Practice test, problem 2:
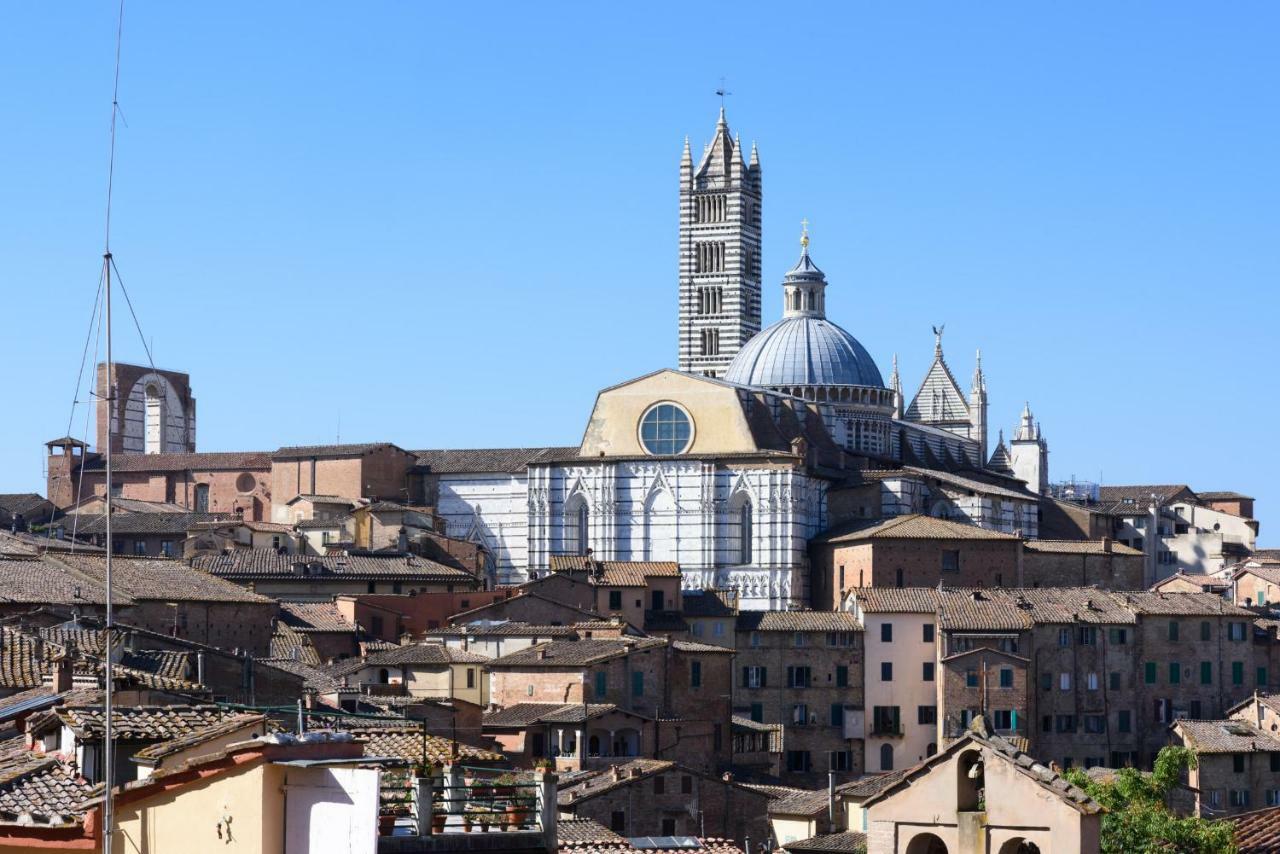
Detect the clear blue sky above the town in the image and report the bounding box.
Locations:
[0,0,1280,542]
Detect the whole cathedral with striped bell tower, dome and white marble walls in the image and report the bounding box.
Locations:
[419,109,1048,609]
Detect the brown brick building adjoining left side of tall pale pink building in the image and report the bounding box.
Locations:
[733,611,864,782]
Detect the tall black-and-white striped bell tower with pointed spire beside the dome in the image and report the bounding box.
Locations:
[678,108,760,376]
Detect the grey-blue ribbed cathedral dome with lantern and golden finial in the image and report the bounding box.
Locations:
[724,233,884,388]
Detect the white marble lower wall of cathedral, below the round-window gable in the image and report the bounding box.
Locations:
[438,460,827,609]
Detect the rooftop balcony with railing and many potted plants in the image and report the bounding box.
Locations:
[378,766,557,854]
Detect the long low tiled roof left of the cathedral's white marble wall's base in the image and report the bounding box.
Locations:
[191,548,475,584]
